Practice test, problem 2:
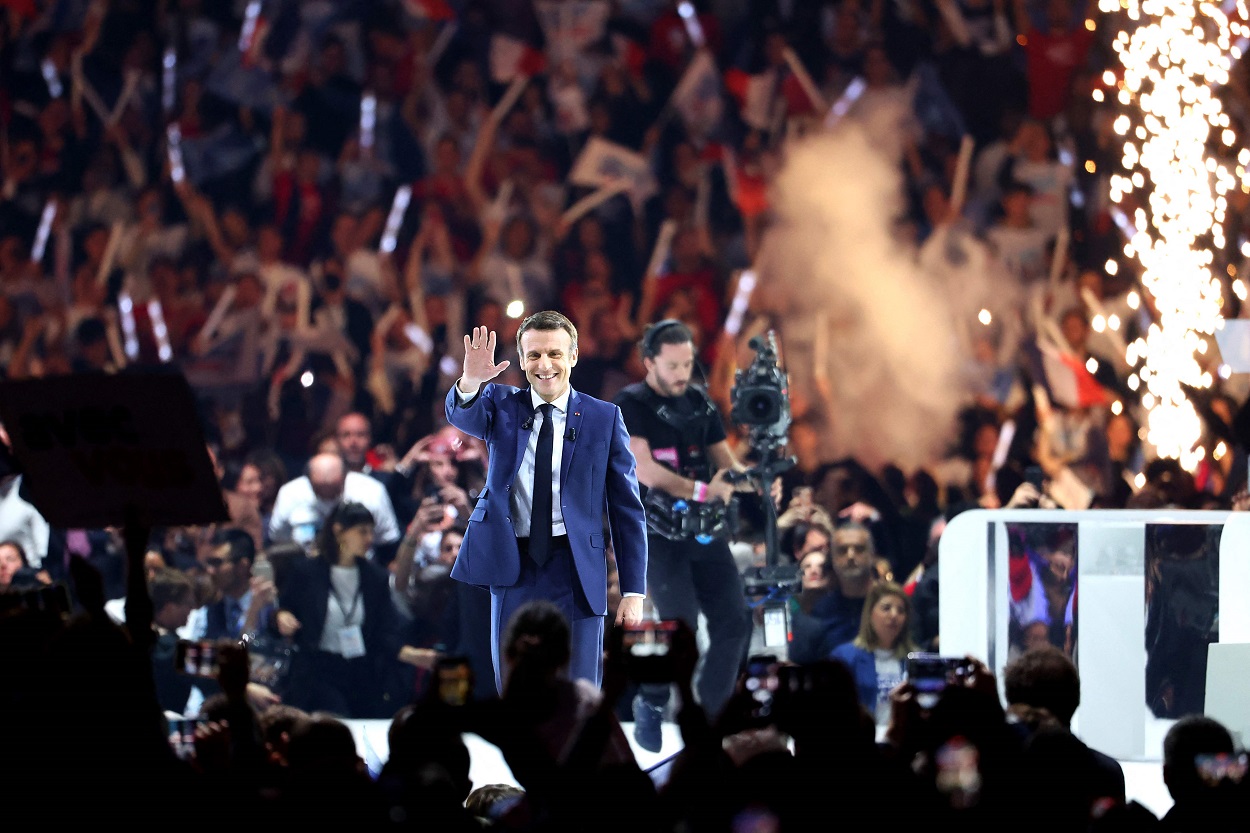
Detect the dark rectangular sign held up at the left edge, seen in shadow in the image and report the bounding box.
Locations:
[0,373,229,529]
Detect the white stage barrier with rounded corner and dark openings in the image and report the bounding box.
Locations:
[939,509,1230,760]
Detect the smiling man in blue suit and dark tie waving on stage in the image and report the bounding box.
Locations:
[446,311,646,692]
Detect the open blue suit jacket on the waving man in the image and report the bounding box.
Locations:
[446,384,646,615]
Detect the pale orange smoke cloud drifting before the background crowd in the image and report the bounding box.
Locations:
[759,121,964,470]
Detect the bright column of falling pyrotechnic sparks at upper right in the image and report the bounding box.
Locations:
[1095,0,1250,469]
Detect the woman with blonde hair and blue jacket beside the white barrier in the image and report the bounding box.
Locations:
[830,582,916,723]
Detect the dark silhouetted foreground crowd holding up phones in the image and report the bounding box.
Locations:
[7,520,1248,830]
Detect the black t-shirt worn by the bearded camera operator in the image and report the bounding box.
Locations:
[614,381,725,494]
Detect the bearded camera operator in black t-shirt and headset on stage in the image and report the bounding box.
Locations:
[615,319,751,752]
